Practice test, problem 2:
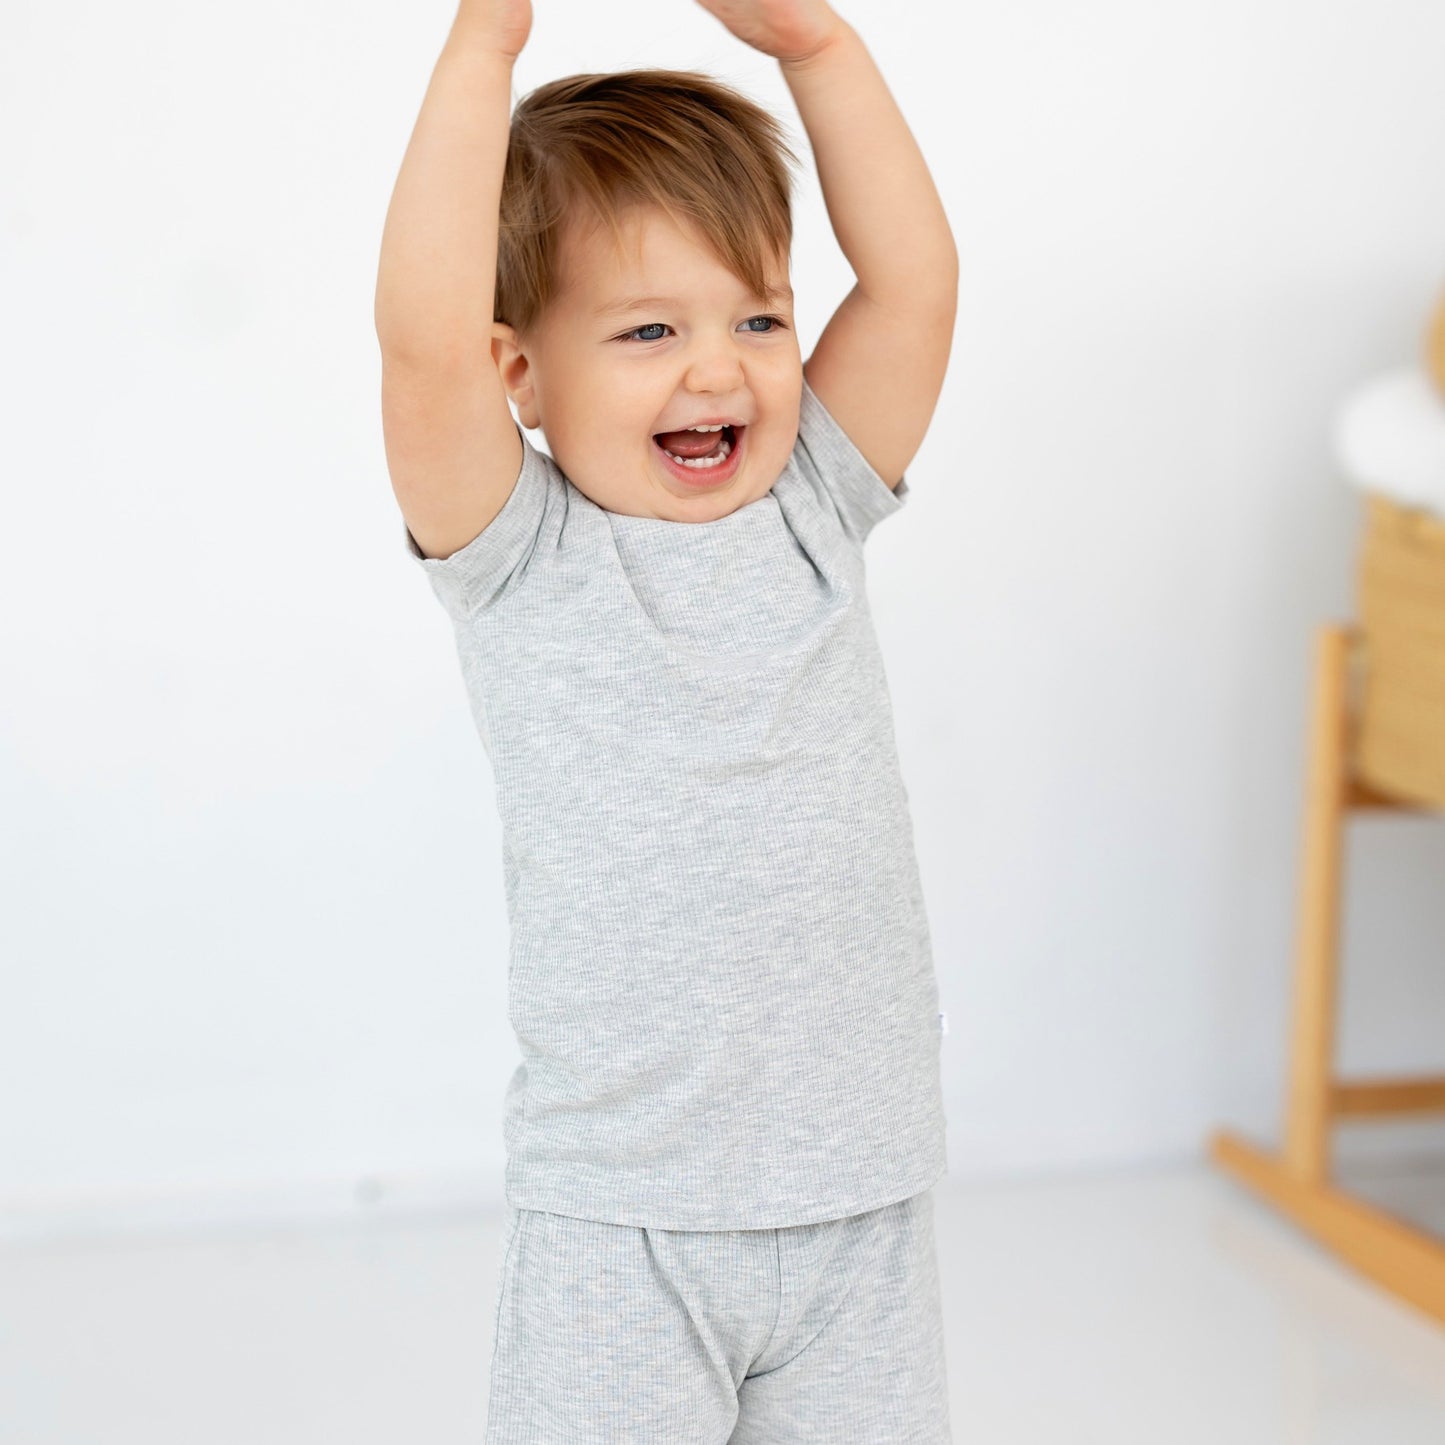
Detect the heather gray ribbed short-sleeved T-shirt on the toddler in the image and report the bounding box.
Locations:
[406,389,946,1230]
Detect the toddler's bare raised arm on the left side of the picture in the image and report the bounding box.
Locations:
[376,0,532,556]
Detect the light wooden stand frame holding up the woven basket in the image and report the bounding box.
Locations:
[1209,623,1445,1324]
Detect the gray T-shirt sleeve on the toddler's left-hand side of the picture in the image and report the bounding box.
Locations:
[403,428,566,620]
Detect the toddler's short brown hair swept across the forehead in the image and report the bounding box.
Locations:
[494,71,796,331]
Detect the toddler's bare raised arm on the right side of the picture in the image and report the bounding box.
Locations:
[699,0,958,487]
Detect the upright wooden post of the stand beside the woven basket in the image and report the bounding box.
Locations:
[1285,624,1354,1183]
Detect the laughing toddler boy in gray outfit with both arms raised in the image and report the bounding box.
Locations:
[376,0,958,1445]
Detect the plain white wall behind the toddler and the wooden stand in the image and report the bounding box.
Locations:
[0,0,1445,1231]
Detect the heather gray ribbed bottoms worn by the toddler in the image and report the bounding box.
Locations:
[486,1189,952,1445]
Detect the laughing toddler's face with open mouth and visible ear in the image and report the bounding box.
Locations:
[497,210,803,522]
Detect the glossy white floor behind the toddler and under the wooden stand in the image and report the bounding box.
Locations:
[0,1166,1445,1445]
